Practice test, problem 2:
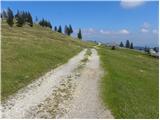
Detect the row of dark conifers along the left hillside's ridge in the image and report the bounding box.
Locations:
[1,8,82,39]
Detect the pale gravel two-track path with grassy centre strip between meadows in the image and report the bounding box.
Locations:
[2,49,113,118]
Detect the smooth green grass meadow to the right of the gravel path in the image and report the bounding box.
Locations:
[98,47,159,118]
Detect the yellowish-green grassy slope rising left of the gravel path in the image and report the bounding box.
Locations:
[1,23,93,100]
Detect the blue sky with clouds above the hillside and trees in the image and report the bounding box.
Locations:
[1,0,159,46]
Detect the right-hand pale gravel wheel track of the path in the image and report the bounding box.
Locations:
[61,49,113,119]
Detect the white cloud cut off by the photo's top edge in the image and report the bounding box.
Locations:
[120,0,144,8]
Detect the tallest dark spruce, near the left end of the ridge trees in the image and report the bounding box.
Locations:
[7,8,14,27]
